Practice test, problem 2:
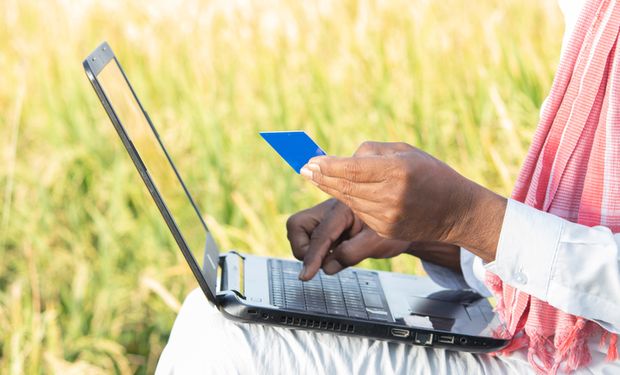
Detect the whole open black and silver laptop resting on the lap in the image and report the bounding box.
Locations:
[83,42,509,352]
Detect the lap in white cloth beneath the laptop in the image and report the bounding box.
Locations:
[156,289,532,375]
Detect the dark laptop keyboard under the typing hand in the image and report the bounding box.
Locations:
[269,259,391,321]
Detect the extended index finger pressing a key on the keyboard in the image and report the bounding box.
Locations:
[299,205,353,281]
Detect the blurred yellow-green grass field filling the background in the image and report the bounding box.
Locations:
[0,0,563,374]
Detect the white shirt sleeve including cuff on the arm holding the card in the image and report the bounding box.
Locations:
[484,200,620,333]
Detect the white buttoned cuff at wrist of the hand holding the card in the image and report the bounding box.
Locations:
[485,199,564,301]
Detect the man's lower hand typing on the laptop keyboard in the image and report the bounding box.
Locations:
[286,199,410,281]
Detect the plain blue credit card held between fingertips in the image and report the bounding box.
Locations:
[260,130,326,173]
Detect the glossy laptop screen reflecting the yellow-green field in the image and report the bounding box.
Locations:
[88,47,219,295]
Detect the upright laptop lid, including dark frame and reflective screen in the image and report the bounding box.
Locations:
[83,42,219,303]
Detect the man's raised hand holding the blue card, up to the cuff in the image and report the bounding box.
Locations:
[302,142,506,261]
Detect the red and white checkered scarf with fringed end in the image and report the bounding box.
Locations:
[486,0,620,373]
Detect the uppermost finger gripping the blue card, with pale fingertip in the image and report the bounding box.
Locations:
[302,155,395,182]
